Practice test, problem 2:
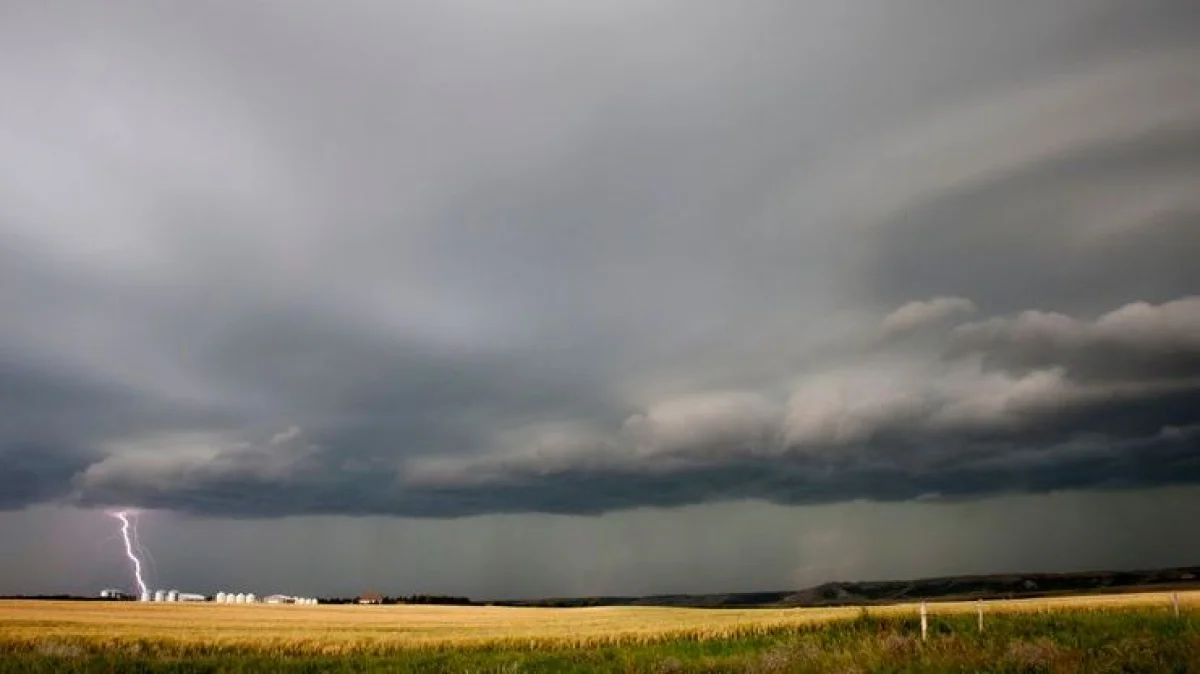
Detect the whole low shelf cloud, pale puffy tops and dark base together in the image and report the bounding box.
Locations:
[68,347,1200,517]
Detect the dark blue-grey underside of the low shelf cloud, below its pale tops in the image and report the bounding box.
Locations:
[68,392,1200,518]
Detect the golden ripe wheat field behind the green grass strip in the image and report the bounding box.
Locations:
[0,591,1200,654]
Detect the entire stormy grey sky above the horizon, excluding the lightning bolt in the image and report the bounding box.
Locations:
[0,0,1200,598]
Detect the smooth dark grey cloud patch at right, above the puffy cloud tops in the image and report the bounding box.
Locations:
[868,128,1200,312]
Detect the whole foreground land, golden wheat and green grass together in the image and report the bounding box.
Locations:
[0,594,1200,673]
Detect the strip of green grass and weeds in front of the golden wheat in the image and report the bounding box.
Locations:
[0,609,1200,674]
